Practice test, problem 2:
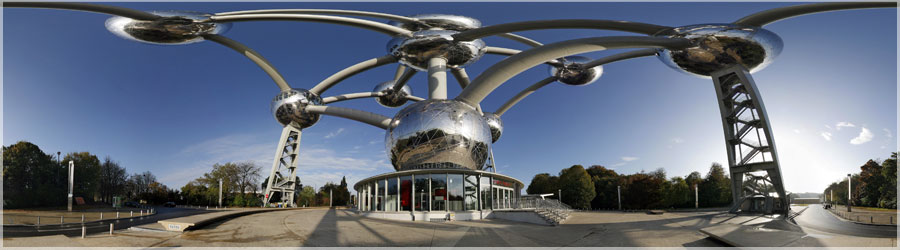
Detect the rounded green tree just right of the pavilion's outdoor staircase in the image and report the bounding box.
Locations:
[559,165,596,209]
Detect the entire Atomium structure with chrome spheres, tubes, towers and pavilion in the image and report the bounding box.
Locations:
[3,2,897,218]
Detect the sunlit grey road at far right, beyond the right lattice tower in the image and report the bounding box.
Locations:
[794,204,897,238]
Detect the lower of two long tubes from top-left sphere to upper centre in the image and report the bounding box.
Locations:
[209,14,412,36]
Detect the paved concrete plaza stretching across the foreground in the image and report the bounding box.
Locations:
[3,209,896,247]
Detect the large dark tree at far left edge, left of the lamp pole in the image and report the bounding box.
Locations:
[3,141,68,208]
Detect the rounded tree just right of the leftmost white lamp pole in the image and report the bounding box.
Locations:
[62,152,100,200]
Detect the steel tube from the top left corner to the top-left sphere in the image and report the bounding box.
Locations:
[3,2,160,21]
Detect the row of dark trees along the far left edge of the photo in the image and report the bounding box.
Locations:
[3,141,177,208]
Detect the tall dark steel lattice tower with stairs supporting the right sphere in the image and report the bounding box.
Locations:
[711,65,788,215]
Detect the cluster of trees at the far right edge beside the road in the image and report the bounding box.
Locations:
[822,152,897,209]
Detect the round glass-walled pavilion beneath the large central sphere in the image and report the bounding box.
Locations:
[354,171,521,212]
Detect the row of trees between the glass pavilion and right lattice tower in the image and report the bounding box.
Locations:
[526,163,732,210]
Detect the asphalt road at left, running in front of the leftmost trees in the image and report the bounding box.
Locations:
[3,207,214,237]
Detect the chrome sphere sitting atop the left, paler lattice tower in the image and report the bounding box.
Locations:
[271,89,322,128]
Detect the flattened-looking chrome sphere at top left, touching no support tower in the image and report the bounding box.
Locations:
[106,11,231,45]
